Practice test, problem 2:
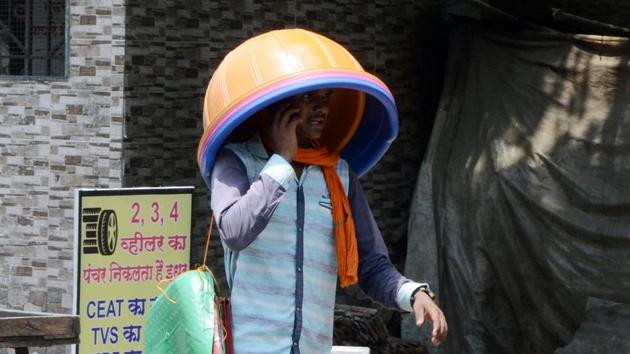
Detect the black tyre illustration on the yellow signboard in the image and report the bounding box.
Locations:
[82,208,118,256]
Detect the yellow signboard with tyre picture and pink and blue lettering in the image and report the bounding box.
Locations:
[74,187,193,354]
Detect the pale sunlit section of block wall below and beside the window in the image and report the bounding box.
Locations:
[0,0,125,353]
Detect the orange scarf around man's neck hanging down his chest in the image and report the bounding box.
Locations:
[294,147,359,288]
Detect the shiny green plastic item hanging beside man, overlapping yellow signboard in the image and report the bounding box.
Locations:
[144,267,218,354]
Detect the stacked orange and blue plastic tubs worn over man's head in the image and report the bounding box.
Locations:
[197,29,398,185]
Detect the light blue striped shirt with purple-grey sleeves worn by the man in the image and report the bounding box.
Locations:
[211,136,421,354]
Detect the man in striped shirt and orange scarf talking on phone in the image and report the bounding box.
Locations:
[211,90,447,354]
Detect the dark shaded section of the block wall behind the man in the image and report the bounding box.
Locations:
[123,0,445,301]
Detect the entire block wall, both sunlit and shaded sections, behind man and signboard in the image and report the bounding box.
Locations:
[0,0,450,353]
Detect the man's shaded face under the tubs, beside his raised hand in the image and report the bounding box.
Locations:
[291,89,332,147]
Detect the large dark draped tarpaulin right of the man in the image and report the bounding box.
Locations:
[406,15,630,354]
